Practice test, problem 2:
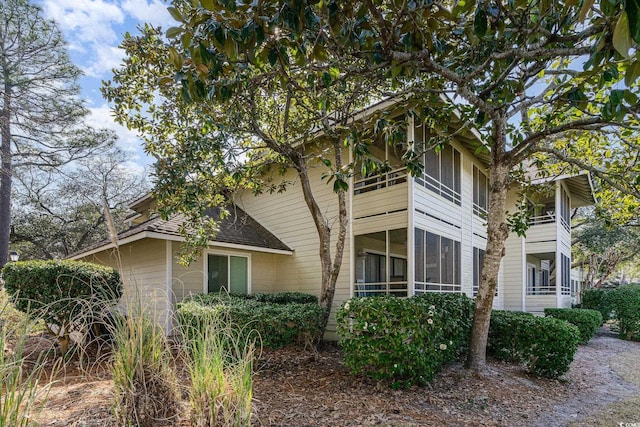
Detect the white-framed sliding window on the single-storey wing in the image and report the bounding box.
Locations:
[207,254,249,294]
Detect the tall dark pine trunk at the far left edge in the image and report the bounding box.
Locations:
[0,78,12,269]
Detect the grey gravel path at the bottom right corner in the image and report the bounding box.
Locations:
[530,326,640,427]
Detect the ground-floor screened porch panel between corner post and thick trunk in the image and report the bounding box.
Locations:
[415,228,462,292]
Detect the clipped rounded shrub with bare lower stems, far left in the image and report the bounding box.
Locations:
[2,260,122,354]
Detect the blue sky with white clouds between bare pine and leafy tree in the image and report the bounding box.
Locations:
[37,0,175,166]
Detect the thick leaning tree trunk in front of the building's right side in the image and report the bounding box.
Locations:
[466,159,510,372]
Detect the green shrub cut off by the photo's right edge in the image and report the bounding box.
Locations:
[609,285,640,341]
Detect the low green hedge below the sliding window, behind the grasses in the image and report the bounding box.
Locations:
[176,294,325,348]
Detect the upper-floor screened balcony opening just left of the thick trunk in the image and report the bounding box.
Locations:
[416,144,461,206]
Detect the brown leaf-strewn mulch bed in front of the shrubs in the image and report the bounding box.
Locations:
[27,326,636,427]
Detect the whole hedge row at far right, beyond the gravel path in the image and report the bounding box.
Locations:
[582,285,640,341]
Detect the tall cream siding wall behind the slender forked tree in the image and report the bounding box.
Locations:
[234,152,351,338]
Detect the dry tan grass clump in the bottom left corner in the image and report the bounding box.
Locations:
[0,300,60,427]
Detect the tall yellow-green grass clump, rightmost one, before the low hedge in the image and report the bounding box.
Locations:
[183,305,257,427]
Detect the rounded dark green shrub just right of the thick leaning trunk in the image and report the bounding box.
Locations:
[487,310,580,378]
